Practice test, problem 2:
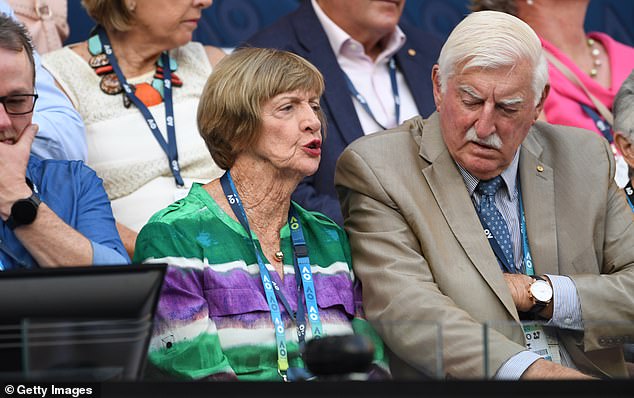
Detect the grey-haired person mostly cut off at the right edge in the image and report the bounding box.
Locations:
[614,70,634,211]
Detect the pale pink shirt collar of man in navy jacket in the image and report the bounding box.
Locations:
[311,0,407,63]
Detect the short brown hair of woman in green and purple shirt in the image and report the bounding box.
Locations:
[198,48,326,170]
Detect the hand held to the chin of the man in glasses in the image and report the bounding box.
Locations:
[0,124,38,221]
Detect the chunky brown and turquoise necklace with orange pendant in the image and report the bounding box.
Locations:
[88,34,183,108]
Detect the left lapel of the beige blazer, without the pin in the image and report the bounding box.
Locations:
[420,113,519,321]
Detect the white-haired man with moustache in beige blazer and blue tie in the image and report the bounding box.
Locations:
[336,11,634,379]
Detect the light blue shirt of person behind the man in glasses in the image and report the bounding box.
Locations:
[0,0,86,160]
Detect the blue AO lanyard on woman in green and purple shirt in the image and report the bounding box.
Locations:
[220,170,323,380]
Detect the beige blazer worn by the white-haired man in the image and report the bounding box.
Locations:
[335,114,634,378]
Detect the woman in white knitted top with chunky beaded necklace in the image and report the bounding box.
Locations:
[43,0,224,255]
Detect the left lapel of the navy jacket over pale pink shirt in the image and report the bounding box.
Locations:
[292,1,363,144]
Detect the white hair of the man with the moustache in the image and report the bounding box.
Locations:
[438,11,548,105]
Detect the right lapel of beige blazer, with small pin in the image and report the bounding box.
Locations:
[520,127,559,274]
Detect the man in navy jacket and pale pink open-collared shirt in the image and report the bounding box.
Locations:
[242,0,441,224]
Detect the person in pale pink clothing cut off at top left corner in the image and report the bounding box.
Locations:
[8,0,70,54]
